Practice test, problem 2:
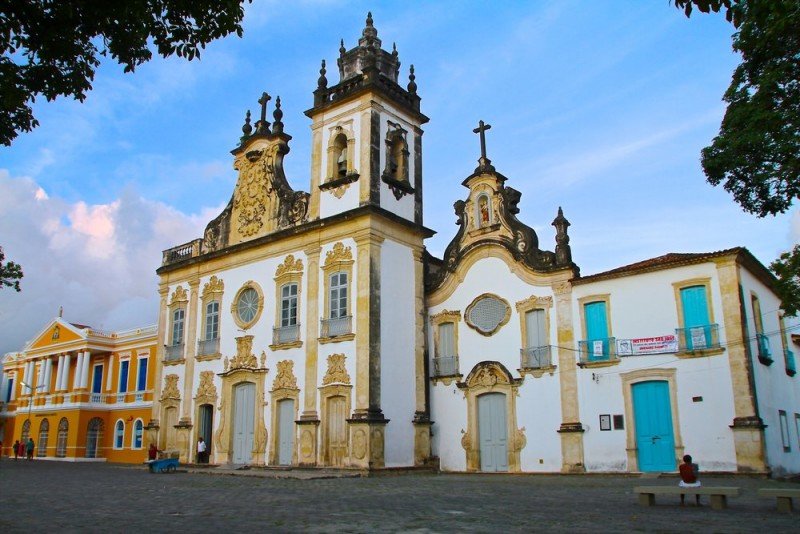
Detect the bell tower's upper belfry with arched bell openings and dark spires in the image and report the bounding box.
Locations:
[306,13,428,225]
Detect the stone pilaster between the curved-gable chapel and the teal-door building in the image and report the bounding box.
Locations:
[553,281,586,473]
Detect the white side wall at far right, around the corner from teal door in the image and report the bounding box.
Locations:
[739,269,800,476]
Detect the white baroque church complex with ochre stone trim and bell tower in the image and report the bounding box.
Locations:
[1,15,800,474]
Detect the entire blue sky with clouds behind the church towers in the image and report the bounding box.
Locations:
[0,0,800,354]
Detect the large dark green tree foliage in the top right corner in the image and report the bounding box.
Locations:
[675,0,800,217]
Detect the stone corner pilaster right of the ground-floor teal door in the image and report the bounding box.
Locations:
[717,256,768,473]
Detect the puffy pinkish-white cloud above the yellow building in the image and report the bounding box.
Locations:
[0,169,221,354]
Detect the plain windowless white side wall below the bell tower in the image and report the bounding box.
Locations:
[380,239,417,467]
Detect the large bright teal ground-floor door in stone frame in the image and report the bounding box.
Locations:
[633,380,675,472]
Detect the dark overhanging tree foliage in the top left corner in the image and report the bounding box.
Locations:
[0,0,252,145]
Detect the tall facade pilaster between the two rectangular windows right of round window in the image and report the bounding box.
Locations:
[296,245,324,465]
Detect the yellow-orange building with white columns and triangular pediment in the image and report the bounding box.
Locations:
[0,317,156,462]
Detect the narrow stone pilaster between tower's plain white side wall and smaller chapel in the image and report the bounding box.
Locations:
[413,249,432,465]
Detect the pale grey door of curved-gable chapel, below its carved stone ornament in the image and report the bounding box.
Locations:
[478,393,508,471]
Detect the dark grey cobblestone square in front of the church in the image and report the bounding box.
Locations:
[0,458,800,533]
